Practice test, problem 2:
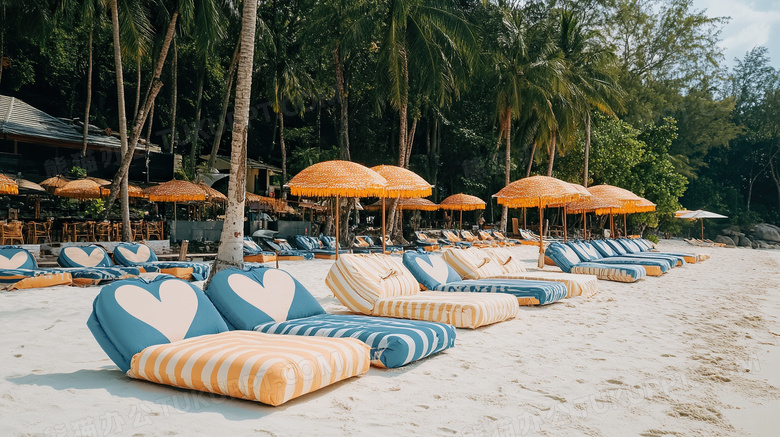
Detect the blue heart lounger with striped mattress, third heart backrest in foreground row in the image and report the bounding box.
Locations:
[404,249,567,305]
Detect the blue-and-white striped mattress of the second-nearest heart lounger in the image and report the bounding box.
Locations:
[255,314,455,368]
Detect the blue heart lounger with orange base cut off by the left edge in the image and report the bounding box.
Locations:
[0,246,73,290]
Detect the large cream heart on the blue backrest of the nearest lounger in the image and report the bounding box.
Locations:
[114,280,203,342]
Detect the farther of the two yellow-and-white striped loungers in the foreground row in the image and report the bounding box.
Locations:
[482,248,599,297]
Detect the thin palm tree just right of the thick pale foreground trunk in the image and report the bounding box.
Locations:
[258,1,314,183]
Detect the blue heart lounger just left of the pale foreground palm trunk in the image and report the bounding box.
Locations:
[114,243,211,281]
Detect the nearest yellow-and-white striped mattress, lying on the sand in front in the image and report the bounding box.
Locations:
[127,331,369,405]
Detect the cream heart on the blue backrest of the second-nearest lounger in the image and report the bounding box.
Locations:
[228,270,295,322]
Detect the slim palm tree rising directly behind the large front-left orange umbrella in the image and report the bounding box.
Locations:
[310,0,374,161]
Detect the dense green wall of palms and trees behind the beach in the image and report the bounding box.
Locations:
[0,0,780,238]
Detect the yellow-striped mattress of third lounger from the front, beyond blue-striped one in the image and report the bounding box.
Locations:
[372,292,517,329]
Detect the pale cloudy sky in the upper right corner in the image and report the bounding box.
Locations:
[693,0,780,69]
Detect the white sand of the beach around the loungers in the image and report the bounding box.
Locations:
[0,241,780,436]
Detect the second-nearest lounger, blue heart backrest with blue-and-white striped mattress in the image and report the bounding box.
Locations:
[206,268,455,368]
